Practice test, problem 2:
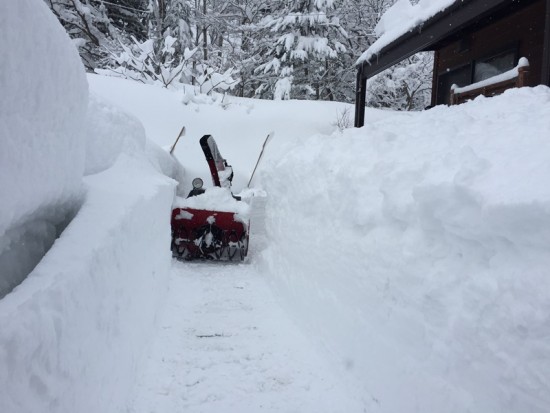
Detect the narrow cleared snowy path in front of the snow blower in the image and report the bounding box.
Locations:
[129,198,364,413]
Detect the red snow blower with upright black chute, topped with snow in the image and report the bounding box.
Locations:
[172,135,249,261]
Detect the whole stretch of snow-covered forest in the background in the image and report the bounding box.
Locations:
[44,0,431,109]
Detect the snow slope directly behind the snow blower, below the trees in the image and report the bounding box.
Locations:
[88,75,353,192]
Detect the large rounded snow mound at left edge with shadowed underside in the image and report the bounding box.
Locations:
[0,0,88,297]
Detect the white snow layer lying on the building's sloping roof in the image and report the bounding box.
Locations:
[356,0,469,65]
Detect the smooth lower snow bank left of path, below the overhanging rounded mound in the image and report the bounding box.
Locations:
[0,156,174,413]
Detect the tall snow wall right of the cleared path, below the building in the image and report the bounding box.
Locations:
[262,87,550,413]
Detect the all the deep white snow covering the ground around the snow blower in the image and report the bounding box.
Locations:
[0,0,550,413]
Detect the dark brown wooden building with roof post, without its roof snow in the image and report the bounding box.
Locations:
[355,0,550,127]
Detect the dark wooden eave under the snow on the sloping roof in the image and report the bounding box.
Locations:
[357,0,548,79]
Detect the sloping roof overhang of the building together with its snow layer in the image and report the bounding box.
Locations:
[356,0,533,77]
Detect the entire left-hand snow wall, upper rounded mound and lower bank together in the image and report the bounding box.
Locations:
[0,0,178,413]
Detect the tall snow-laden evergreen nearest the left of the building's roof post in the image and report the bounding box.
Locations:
[257,0,347,100]
